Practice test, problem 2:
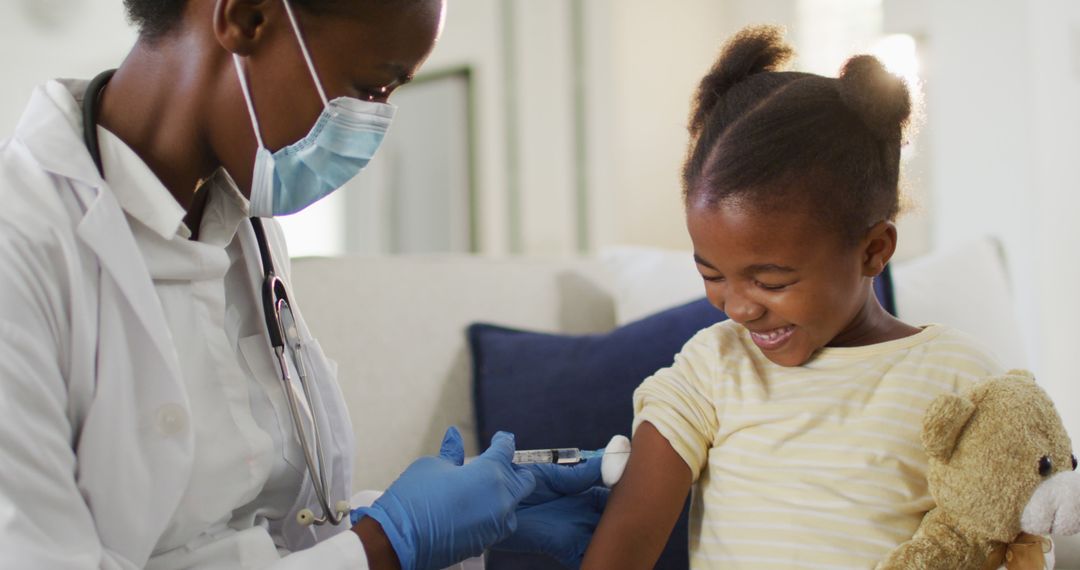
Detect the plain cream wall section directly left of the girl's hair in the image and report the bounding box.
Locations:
[588,0,727,248]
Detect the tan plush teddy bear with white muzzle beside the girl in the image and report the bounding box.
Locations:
[877,370,1080,570]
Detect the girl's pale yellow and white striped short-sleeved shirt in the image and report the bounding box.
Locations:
[634,321,1001,570]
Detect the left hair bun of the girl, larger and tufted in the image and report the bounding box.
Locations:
[689,26,795,135]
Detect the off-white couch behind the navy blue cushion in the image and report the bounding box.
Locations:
[293,241,1080,570]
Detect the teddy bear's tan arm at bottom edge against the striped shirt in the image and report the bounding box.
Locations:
[876,512,985,570]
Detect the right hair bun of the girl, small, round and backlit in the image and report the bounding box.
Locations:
[840,55,912,140]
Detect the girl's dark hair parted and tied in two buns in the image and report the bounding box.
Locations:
[683,27,912,243]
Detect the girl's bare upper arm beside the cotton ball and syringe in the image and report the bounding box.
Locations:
[581,422,693,570]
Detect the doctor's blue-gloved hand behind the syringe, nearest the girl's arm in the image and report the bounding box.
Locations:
[492,460,609,568]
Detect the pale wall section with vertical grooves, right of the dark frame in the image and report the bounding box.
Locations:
[414,0,578,255]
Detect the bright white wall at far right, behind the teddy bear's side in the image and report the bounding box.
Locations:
[886,0,1080,436]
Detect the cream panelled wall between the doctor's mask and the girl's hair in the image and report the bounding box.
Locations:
[428,0,734,255]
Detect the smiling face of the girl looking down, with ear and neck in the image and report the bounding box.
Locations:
[687,199,899,366]
